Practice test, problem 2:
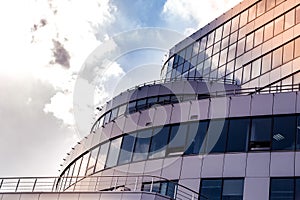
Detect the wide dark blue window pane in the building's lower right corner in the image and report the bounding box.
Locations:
[270,178,294,200]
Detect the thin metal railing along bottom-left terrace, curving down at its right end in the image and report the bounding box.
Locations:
[0,175,206,200]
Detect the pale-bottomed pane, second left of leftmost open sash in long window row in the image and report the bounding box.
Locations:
[132,129,152,161]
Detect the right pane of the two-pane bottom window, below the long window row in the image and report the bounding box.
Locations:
[222,179,244,200]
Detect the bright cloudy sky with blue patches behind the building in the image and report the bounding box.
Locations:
[0,0,239,176]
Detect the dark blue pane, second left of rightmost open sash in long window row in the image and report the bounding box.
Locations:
[206,119,228,153]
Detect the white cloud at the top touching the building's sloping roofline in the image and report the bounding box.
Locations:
[162,0,241,35]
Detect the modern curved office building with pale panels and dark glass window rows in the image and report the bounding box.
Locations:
[0,0,300,200]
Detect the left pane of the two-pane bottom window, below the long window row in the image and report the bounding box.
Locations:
[200,179,222,200]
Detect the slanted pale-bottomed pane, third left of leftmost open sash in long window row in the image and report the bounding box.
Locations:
[118,134,136,165]
